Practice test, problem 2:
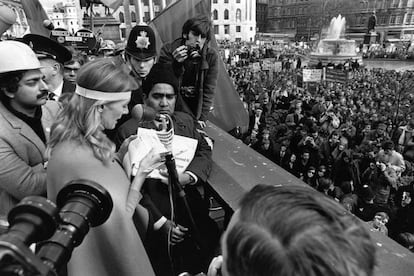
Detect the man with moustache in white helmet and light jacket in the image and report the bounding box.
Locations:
[0,41,60,232]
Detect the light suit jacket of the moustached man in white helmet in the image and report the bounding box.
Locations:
[0,101,60,219]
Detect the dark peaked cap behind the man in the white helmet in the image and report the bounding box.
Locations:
[21,34,72,64]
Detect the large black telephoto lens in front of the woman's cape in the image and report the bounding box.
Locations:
[37,179,113,271]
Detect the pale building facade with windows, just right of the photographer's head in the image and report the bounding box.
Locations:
[211,0,256,42]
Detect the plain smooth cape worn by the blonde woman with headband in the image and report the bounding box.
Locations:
[47,141,154,276]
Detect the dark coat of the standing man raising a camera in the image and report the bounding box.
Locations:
[159,38,219,121]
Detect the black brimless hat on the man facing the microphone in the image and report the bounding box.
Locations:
[142,63,179,95]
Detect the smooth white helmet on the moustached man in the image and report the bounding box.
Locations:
[0,40,41,73]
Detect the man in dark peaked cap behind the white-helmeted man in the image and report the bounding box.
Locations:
[22,34,75,100]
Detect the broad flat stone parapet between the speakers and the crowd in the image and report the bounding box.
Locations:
[206,123,414,276]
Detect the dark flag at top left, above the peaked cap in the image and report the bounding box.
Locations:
[22,0,50,37]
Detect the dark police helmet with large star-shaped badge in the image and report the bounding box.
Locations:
[125,25,157,59]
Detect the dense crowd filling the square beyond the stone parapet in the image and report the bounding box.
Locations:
[228,41,414,248]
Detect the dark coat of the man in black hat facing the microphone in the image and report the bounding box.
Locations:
[117,112,215,275]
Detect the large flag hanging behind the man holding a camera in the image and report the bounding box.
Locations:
[149,0,249,132]
